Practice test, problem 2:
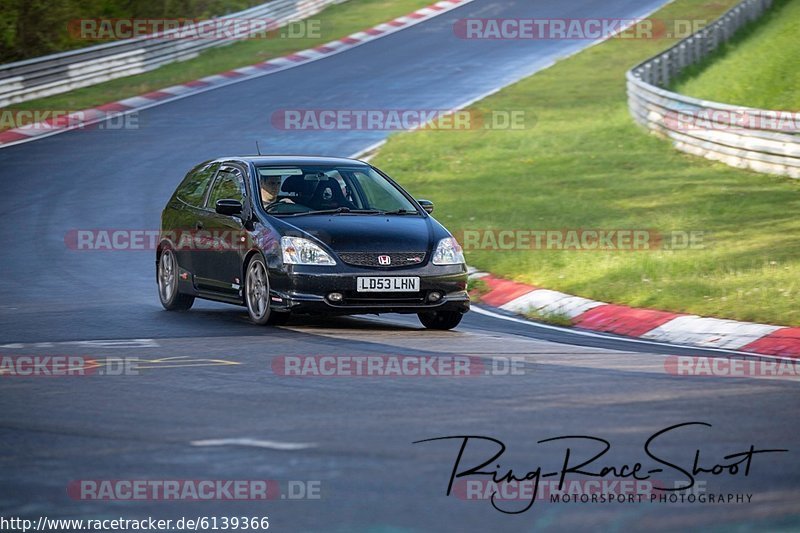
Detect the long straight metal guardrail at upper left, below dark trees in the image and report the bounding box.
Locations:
[0,0,346,107]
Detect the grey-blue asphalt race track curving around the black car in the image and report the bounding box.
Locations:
[0,0,800,532]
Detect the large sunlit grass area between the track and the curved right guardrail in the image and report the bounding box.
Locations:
[373,0,800,325]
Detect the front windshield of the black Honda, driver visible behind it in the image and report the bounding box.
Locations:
[257,165,418,216]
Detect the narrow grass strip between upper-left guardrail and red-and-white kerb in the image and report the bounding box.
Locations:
[8,0,433,114]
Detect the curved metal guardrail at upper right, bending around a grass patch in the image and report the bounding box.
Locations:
[627,0,800,178]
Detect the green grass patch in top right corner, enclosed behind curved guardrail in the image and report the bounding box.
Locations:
[673,0,800,111]
